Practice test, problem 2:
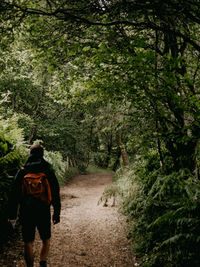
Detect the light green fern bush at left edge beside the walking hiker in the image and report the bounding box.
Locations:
[0,116,27,249]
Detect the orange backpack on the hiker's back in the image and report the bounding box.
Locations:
[22,172,52,205]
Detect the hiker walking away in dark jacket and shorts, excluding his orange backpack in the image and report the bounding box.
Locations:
[9,145,61,267]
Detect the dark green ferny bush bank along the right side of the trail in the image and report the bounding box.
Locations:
[117,157,200,267]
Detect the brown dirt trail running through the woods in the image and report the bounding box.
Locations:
[0,173,138,267]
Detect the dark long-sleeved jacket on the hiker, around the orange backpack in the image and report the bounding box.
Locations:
[8,156,61,222]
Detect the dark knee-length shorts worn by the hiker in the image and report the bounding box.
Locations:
[21,203,51,243]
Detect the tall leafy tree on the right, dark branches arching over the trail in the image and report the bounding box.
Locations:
[2,0,200,171]
